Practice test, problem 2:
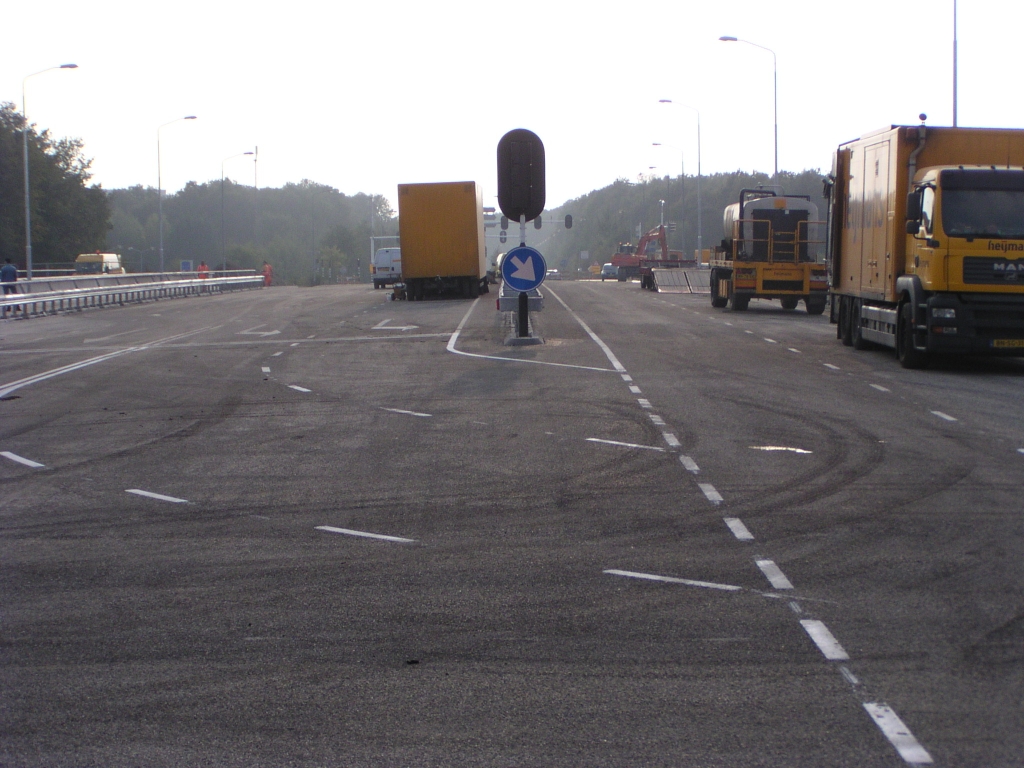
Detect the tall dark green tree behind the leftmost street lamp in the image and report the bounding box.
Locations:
[0,102,111,264]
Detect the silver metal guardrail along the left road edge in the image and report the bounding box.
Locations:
[0,274,263,318]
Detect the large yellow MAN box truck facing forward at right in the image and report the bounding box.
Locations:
[826,122,1024,368]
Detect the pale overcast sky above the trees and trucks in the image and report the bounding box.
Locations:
[6,0,1024,214]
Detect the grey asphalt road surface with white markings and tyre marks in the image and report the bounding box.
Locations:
[0,282,1024,768]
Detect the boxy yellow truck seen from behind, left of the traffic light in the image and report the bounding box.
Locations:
[396,181,487,301]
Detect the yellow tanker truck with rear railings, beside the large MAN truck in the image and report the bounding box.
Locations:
[710,187,828,314]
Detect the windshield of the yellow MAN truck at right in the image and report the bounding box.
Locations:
[941,169,1024,240]
